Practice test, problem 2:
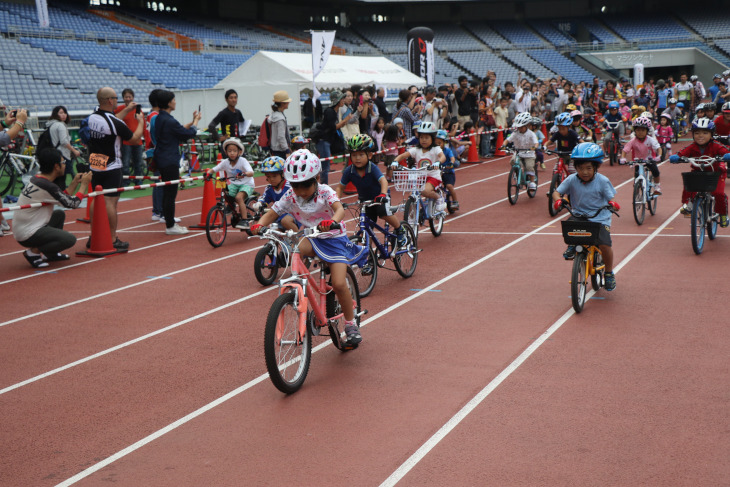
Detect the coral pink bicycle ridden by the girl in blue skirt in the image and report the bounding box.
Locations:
[252,224,367,394]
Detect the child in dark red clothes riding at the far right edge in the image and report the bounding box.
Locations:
[669,118,730,228]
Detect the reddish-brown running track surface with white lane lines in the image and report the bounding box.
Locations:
[0,146,730,486]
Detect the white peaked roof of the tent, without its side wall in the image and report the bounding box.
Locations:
[215,51,426,93]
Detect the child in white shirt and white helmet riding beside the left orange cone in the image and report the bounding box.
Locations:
[205,137,255,229]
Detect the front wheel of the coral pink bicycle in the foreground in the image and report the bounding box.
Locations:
[264,292,312,394]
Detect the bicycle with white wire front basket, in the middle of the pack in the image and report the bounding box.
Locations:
[393,164,446,238]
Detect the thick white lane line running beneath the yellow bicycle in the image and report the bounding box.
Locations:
[380,214,677,487]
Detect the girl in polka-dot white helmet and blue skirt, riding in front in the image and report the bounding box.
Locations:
[251,149,368,345]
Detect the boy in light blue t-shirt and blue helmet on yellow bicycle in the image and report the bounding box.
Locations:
[552,142,620,291]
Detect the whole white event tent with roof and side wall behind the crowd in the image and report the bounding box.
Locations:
[172,51,426,135]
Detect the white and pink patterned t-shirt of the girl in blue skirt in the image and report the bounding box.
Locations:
[271,183,347,238]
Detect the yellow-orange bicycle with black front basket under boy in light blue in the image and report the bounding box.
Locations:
[560,203,620,313]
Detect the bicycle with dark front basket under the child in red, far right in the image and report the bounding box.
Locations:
[679,156,722,255]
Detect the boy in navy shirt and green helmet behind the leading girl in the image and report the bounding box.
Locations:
[336,134,408,247]
